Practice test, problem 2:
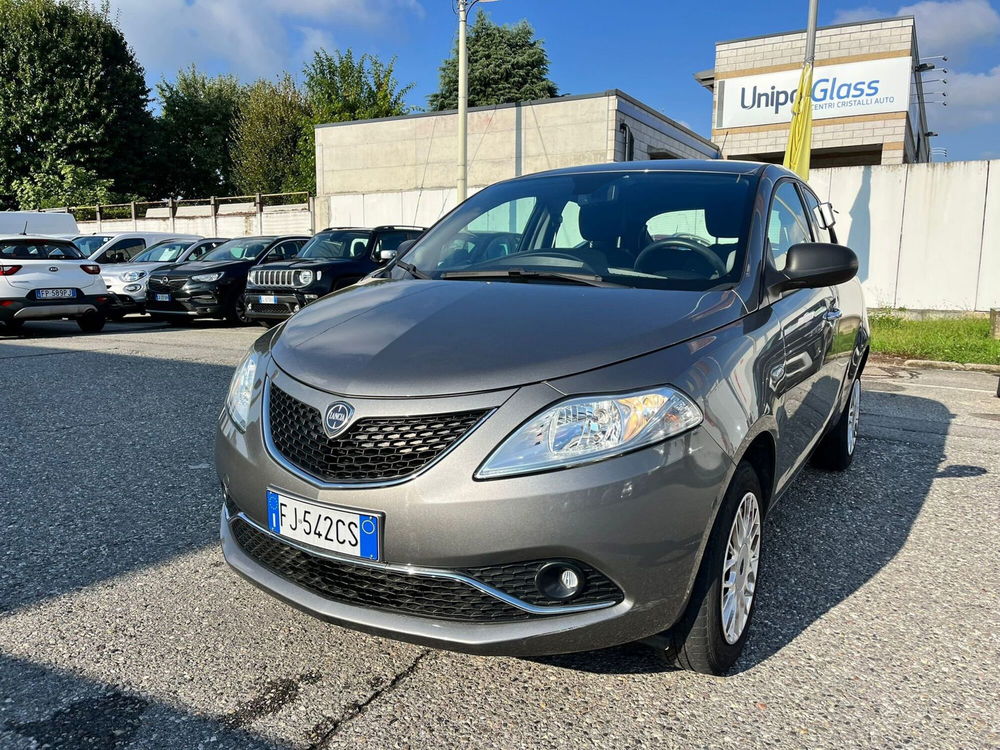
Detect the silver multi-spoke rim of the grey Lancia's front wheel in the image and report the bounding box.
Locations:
[720,492,761,644]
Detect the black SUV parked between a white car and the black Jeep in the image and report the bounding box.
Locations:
[146,235,309,324]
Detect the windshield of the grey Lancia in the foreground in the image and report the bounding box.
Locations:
[403,171,756,290]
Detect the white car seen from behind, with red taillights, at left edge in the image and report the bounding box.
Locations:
[0,235,110,333]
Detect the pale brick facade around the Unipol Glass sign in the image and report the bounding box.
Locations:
[712,18,915,164]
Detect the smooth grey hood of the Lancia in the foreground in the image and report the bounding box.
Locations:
[271,280,744,398]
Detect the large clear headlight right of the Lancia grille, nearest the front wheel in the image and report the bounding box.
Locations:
[476,387,702,479]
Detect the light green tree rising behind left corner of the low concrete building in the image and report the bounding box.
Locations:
[295,49,413,192]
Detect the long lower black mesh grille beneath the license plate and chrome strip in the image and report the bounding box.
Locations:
[232,519,532,622]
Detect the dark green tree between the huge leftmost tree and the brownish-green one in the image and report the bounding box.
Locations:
[155,65,245,198]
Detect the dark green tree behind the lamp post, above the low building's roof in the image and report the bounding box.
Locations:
[429,12,559,111]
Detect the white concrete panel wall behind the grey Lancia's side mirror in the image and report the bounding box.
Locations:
[809,160,1000,311]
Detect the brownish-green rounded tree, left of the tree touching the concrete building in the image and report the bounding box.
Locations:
[232,73,308,195]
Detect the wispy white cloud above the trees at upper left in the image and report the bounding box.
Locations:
[112,0,424,78]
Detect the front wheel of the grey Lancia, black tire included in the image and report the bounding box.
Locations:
[661,461,764,676]
